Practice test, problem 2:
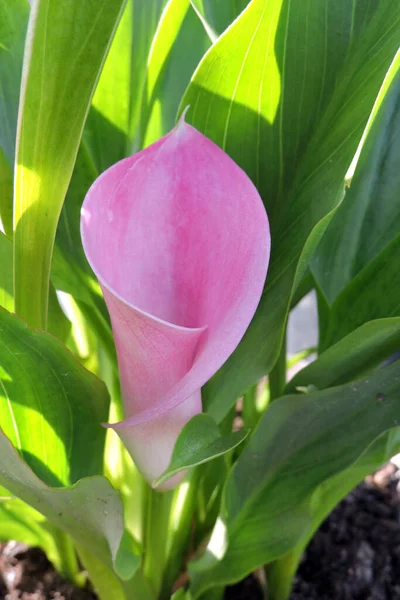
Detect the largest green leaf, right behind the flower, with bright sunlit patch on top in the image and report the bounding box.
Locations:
[181,0,400,420]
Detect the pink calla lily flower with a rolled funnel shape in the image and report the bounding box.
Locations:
[81,118,270,489]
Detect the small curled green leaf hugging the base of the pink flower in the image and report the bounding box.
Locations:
[153,414,249,487]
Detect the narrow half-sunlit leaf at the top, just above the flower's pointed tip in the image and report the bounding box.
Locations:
[141,0,210,146]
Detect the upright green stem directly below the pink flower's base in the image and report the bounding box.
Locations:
[143,487,173,598]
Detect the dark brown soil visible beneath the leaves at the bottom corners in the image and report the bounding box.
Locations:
[0,465,400,600]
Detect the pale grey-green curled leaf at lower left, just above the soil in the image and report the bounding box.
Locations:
[0,429,129,571]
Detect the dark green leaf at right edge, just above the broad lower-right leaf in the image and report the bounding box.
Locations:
[321,235,400,349]
